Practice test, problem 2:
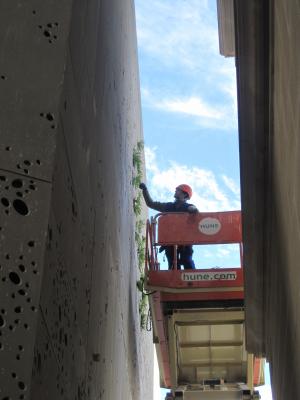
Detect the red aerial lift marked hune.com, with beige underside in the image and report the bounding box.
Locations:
[145,211,264,400]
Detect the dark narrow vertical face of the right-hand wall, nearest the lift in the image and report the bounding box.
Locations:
[235,0,269,355]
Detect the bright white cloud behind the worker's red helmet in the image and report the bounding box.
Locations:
[145,147,240,212]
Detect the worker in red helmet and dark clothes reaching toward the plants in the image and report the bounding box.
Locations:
[140,183,198,269]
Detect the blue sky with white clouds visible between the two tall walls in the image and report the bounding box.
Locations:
[135,0,271,400]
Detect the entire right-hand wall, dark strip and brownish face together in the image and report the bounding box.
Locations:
[236,0,300,400]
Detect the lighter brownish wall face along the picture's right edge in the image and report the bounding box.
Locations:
[265,0,300,399]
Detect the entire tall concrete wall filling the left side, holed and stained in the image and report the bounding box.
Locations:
[0,0,153,400]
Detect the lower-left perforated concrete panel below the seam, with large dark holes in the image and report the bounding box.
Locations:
[0,171,50,399]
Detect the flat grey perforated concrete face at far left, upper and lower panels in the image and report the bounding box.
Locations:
[0,0,71,400]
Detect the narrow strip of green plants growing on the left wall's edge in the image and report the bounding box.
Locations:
[132,141,148,329]
